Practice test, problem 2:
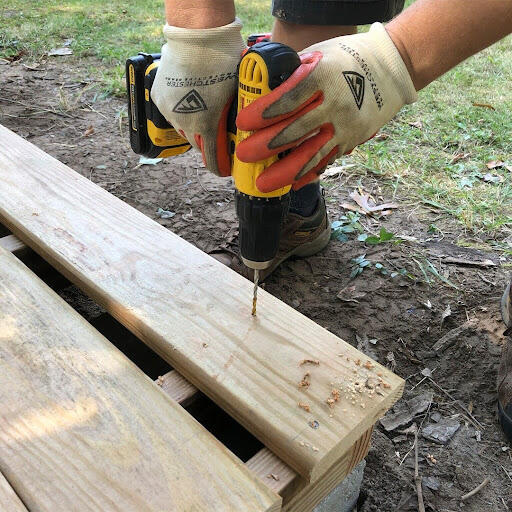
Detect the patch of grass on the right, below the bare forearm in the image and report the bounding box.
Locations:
[345,37,512,239]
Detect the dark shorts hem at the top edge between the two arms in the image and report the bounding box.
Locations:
[272,0,404,25]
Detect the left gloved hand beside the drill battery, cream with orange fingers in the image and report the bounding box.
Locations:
[151,19,245,176]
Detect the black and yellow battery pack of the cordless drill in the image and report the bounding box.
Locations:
[126,53,191,158]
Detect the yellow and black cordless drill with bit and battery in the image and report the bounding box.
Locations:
[126,38,300,315]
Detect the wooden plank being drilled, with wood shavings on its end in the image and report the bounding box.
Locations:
[0,127,403,480]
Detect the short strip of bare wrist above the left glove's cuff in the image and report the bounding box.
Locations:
[165,0,235,28]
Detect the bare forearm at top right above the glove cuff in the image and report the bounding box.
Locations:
[386,0,512,91]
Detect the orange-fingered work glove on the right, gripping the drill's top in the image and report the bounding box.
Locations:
[236,23,417,192]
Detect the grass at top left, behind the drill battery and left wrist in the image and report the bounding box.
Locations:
[0,0,272,96]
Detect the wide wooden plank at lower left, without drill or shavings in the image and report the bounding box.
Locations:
[0,249,281,512]
